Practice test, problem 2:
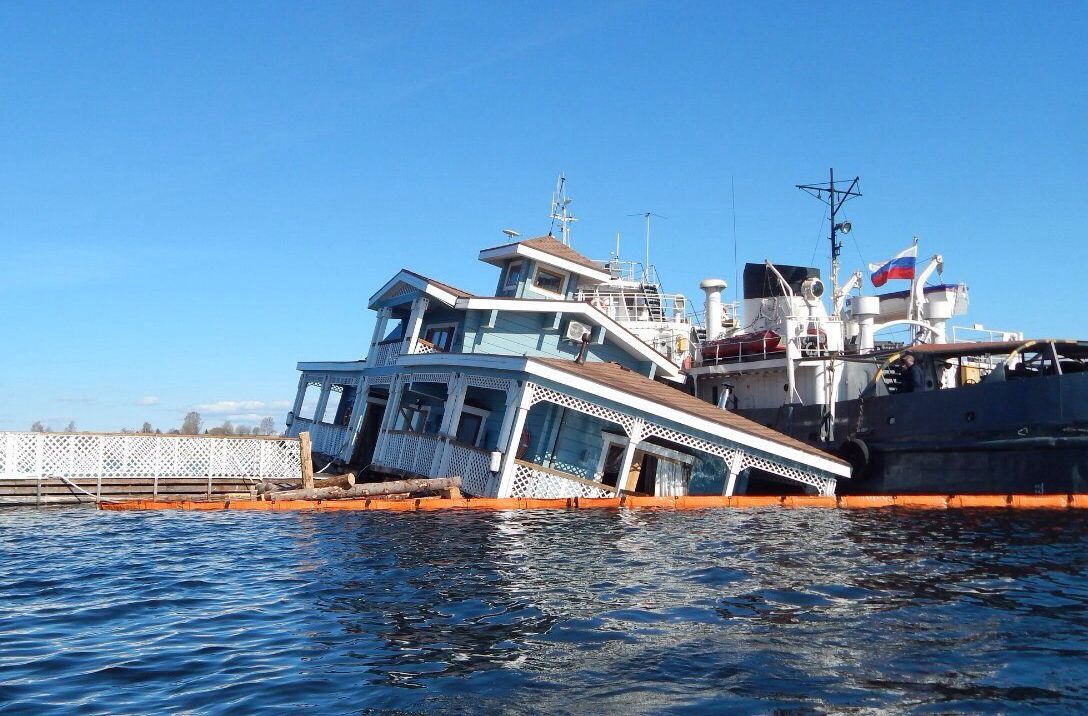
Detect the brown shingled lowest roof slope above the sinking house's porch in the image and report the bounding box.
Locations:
[533,358,846,465]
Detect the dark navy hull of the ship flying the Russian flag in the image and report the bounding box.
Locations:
[738,373,1088,494]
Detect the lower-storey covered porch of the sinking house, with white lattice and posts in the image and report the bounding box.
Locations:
[355,356,849,497]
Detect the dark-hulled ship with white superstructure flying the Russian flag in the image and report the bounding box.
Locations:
[687,171,1088,494]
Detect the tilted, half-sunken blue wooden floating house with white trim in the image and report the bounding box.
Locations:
[288,236,850,497]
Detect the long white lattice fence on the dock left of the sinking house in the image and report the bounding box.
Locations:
[0,432,301,478]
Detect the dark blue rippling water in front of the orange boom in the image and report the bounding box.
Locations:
[0,509,1088,714]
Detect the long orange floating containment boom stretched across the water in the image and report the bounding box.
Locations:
[99,495,1088,513]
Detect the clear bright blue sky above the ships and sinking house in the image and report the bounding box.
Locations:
[0,1,1088,430]
